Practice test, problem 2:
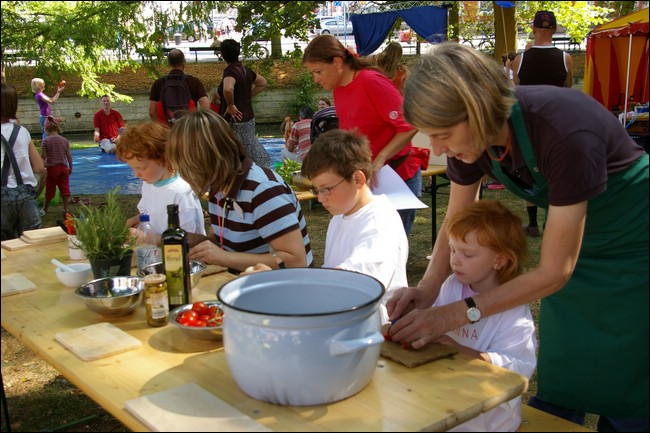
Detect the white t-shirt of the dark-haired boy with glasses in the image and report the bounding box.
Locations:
[323,195,409,323]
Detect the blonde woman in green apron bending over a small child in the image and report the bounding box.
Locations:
[387,43,650,431]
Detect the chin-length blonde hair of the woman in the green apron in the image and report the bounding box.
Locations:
[404,42,515,150]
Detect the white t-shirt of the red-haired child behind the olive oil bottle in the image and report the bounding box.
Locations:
[138,175,205,235]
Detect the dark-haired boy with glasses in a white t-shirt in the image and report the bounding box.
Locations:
[246,129,408,323]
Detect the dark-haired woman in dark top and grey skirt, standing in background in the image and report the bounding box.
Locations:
[219,39,271,167]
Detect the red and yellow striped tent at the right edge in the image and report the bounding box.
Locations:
[584,9,648,111]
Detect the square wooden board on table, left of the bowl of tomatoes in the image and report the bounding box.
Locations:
[54,322,142,361]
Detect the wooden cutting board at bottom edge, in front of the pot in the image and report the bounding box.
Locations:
[124,383,271,432]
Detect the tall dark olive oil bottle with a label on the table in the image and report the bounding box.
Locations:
[161,204,192,310]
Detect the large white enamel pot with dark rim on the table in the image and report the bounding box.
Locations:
[217,268,385,406]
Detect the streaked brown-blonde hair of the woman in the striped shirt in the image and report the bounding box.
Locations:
[165,110,246,197]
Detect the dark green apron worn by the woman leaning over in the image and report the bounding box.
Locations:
[492,104,650,418]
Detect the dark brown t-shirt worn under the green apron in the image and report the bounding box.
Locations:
[447,86,644,206]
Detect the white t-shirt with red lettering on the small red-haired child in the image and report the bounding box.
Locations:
[433,275,537,432]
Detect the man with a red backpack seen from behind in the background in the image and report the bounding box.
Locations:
[149,48,210,126]
